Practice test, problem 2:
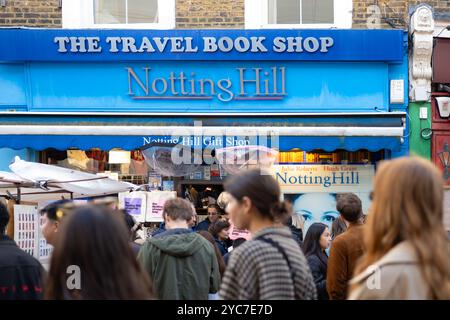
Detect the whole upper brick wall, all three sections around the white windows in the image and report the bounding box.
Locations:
[0,0,450,29]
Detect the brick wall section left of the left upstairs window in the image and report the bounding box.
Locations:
[0,0,61,28]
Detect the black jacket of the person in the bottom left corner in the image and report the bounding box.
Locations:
[0,235,44,300]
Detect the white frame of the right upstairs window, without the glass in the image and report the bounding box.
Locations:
[244,0,353,29]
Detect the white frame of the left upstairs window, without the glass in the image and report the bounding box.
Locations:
[62,0,175,29]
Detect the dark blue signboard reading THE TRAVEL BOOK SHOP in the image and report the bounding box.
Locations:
[0,28,404,63]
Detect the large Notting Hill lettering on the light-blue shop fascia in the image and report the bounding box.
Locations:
[126,66,287,102]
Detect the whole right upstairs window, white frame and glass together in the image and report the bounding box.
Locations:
[245,0,353,29]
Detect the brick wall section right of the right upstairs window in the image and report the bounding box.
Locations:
[353,0,450,29]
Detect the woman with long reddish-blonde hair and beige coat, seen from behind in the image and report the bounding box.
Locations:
[349,158,450,300]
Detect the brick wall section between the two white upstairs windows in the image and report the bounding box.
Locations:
[176,0,244,29]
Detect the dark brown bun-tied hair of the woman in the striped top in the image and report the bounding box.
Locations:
[224,169,292,222]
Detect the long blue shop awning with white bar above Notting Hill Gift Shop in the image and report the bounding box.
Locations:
[0,112,406,151]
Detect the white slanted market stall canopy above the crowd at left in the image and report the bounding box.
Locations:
[9,157,137,197]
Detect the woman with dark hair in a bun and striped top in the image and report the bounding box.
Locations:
[219,170,316,300]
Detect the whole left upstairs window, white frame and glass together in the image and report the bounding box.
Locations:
[62,0,175,29]
